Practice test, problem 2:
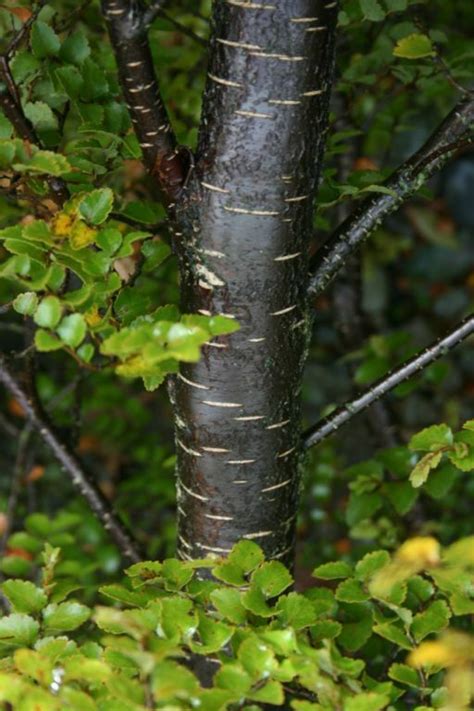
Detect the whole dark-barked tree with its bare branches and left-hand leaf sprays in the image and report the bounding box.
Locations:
[0,0,474,564]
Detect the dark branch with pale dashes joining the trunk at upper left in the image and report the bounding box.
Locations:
[102,0,186,203]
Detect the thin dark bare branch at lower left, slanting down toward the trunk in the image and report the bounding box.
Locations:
[0,356,142,562]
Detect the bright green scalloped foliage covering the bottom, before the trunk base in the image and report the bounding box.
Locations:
[0,538,474,711]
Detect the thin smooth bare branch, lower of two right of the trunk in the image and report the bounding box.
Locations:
[303,315,474,449]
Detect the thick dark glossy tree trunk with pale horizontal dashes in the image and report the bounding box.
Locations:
[172,0,337,562]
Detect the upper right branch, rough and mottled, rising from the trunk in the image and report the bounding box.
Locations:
[308,98,474,297]
